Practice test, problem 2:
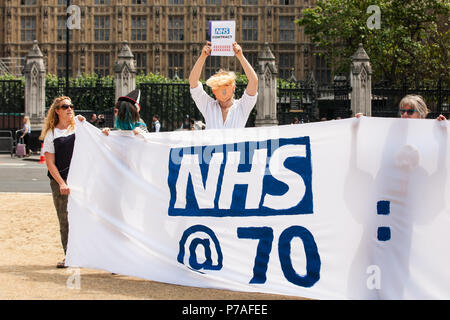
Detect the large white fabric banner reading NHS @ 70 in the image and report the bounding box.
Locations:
[66,117,450,299]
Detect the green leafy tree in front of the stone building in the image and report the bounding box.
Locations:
[296,0,450,83]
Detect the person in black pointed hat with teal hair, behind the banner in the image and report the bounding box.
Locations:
[102,89,148,135]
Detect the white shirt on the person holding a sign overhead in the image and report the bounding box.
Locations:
[191,82,258,129]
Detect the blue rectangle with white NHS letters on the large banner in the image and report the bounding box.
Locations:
[167,137,314,217]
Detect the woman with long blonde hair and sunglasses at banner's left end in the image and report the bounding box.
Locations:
[39,96,85,268]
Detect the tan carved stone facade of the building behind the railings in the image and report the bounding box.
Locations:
[0,0,315,79]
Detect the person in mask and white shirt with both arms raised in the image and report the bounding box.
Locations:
[189,41,258,129]
